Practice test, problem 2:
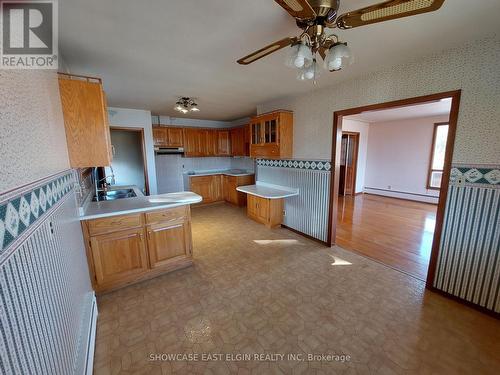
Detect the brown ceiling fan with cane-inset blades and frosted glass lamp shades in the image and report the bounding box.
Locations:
[238,0,444,80]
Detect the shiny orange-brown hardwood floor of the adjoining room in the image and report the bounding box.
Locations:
[336,194,437,280]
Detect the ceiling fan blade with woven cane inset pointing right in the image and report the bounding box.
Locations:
[337,0,444,29]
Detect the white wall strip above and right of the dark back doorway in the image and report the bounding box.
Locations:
[108,107,157,195]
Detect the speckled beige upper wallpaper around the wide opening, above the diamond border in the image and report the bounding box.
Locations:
[257,37,500,164]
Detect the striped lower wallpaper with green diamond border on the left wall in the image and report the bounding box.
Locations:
[0,171,94,375]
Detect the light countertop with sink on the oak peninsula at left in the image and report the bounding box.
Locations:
[79,191,202,220]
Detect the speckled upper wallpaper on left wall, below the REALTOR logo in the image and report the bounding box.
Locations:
[0,70,69,192]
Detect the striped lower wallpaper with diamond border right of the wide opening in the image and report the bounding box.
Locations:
[434,166,500,312]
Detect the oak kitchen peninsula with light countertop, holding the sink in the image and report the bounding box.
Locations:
[80,192,202,293]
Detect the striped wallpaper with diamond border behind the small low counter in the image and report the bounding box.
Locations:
[257,159,331,242]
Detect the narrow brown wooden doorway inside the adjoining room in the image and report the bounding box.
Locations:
[339,131,359,195]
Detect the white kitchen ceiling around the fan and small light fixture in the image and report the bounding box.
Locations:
[59,0,500,120]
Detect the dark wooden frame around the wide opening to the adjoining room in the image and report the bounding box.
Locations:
[327,90,462,288]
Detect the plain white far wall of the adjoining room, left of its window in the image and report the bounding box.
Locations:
[365,116,448,203]
